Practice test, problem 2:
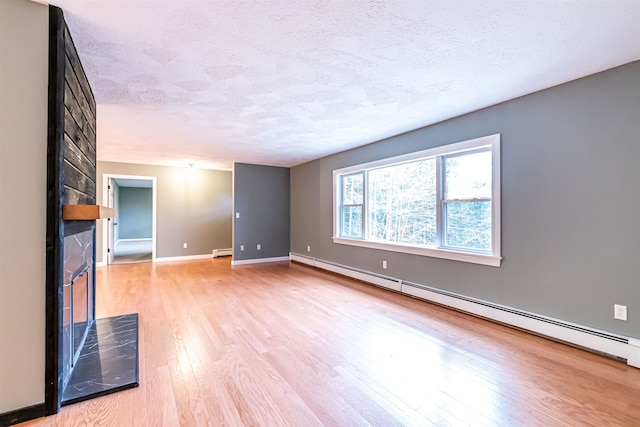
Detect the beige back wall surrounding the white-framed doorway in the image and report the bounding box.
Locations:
[97,162,232,262]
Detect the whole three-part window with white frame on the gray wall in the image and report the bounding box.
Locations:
[333,134,501,266]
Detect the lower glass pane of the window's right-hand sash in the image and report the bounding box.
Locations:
[444,201,491,251]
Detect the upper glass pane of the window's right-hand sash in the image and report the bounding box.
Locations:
[444,151,491,200]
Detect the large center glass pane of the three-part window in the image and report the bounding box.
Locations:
[367,159,436,246]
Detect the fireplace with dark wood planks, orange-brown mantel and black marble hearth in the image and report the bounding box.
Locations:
[46,7,138,415]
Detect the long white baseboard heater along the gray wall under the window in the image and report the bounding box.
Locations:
[290,253,640,368]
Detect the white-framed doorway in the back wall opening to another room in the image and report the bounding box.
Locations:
[102,174,157,264]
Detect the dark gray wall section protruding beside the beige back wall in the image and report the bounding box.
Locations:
[233,163,289,261]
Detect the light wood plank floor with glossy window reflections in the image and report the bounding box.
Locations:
[17,258,640,427]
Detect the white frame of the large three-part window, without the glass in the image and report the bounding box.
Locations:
[333,134,502,267]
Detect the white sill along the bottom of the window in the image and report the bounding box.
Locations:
[333,237,502,267]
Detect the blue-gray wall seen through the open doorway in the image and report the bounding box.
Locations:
[115,187,153,239]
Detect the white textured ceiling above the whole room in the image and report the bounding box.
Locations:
[50,0,640,169]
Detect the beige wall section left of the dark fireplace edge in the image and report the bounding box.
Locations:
[0,0,49,413]
